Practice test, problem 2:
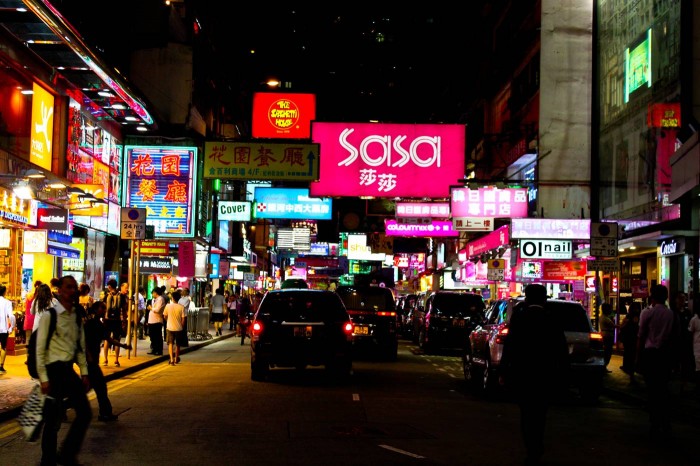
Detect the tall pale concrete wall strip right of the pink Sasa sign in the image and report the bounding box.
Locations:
[538,0,593,218]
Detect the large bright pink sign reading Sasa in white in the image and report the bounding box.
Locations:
[310,122,466,198]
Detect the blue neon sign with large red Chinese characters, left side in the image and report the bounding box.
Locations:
[124,146,197,238]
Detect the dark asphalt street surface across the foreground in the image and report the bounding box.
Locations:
[0,338,700,466]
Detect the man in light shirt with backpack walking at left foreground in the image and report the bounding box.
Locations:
[36,275,92,465]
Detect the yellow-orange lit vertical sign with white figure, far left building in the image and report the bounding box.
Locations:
[29,83,54,171]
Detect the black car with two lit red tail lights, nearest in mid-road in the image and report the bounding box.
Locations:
[250,288,353,380]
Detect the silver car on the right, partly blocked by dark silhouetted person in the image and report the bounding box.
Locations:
[462,298,605,401]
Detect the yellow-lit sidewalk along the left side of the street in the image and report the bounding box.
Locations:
[0,329,234,422]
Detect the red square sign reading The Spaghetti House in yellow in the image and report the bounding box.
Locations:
[253,92,316,139]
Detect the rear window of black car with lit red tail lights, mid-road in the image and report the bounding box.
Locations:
[258,291,348,322]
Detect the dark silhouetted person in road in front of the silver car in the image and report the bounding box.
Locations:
[500,284,569,464]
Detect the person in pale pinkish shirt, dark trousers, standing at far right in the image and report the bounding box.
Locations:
[637,285,676,440]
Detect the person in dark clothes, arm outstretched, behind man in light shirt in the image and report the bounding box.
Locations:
[83,301,131,422]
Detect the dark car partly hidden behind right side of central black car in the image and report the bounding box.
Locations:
[336,285,400,360]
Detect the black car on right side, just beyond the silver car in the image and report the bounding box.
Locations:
[418,291,486,353]
